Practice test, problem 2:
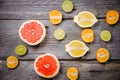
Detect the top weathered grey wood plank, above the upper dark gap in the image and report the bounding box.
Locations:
[0,0,120,19]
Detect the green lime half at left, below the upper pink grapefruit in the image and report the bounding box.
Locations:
[15,44,27,56]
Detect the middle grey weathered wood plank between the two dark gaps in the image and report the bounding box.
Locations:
[0,19,120,59]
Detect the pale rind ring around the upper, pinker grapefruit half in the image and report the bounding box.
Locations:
[19,20,46,46]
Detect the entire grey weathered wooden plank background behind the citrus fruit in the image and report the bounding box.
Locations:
[0,0,120,80]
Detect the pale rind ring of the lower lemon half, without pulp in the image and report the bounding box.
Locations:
[65,40,89,58]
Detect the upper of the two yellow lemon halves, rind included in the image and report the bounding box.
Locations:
[73,11,98,28]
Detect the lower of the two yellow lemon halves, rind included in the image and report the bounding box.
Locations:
[65,40,89,58]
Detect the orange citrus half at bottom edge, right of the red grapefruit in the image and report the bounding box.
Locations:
[67,67,78,80]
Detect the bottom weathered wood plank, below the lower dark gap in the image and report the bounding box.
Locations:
[0,60,120,80]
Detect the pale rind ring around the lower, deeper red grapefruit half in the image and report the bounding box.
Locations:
[34,53,60,78]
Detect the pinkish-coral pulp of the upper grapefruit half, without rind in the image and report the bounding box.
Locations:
[21,22,43,43]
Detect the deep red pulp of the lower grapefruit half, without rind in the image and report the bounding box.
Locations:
[36,56,58,76]
